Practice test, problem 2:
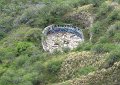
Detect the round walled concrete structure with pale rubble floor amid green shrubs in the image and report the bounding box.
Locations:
[42,24,84,53]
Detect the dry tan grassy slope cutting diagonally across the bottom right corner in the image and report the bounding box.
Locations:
[53,62,120,85]
